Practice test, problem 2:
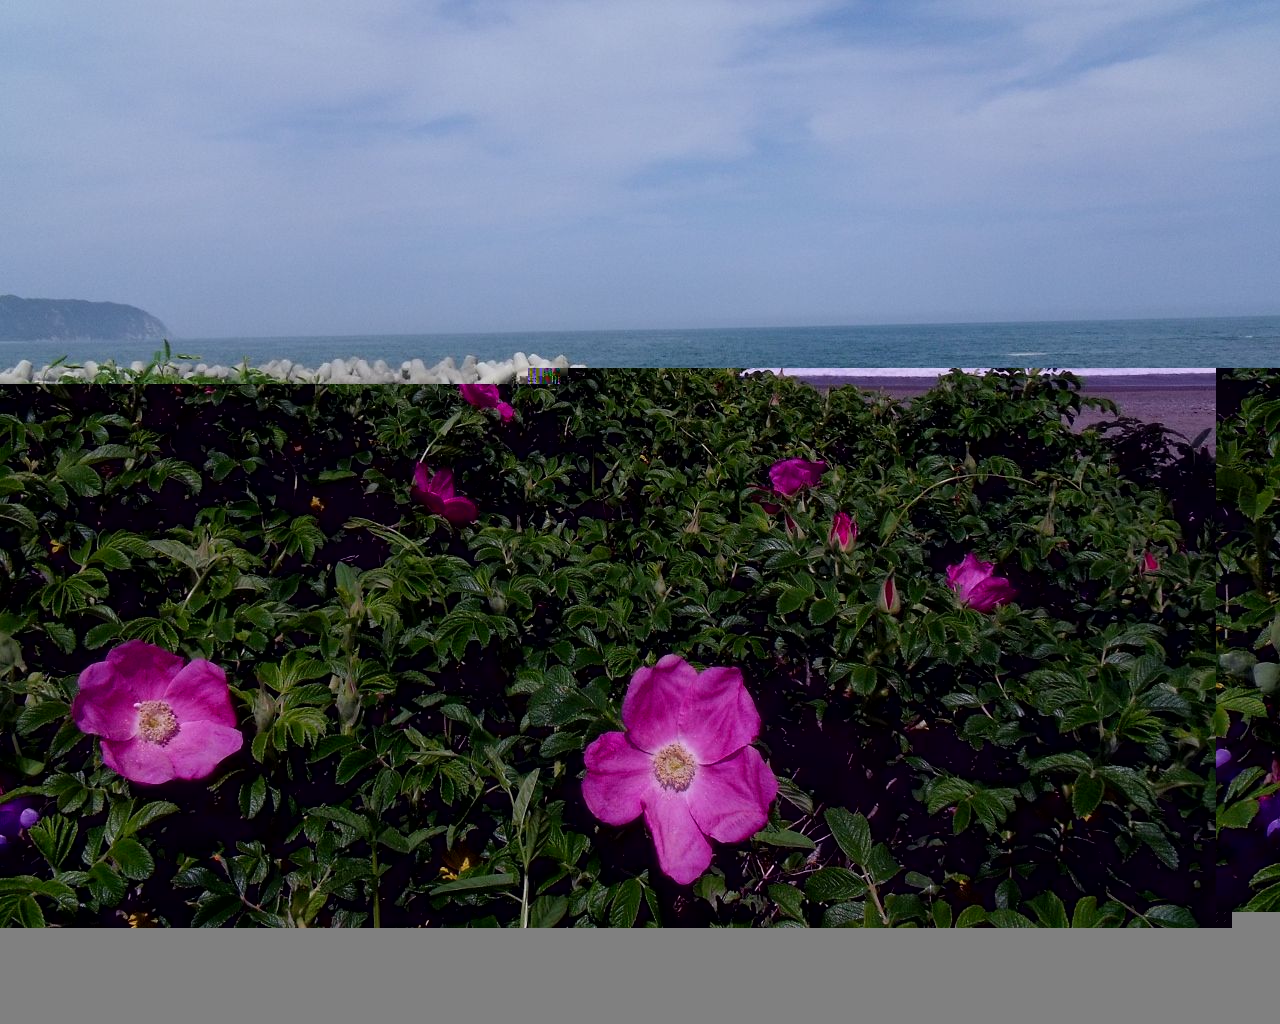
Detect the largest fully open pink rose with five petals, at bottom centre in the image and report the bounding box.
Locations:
[582,654,778,886]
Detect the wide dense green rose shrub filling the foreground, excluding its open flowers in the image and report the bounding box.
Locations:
[0,370,1215,927]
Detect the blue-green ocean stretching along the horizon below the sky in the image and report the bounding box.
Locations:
[0,316,1280,376]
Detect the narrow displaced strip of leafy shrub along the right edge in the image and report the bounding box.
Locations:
[1215,370,1280,910]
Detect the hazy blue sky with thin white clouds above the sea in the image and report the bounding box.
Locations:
[0,0,1280,338]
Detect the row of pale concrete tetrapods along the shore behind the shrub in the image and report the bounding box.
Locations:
[0,352,584,384]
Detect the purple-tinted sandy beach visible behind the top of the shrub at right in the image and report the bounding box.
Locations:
[800,374,1217,451]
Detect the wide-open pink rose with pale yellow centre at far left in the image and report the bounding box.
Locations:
[72,640,244,785]
